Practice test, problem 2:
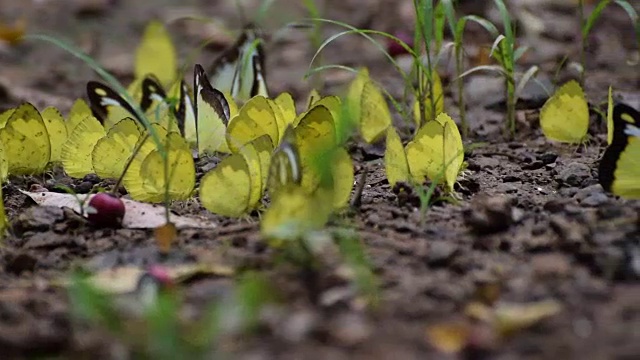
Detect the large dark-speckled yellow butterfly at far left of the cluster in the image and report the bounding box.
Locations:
[0,103,51,175]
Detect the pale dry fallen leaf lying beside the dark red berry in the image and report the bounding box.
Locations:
[20,190,216,229]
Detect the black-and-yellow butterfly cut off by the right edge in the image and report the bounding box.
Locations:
[598,103,640,199]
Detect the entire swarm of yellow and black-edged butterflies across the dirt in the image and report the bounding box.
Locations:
[0,21,640,238]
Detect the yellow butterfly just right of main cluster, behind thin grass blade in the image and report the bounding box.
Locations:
[347,68,391,143]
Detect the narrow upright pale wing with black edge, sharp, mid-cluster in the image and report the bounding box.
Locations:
[193,64,230,155]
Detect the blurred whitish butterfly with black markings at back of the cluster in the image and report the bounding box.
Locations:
[209,24,269,103]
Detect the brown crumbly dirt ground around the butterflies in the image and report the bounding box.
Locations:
[0,0,640,359]
